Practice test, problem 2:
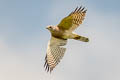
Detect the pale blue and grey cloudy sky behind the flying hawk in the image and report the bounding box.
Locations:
[0,0,120,80]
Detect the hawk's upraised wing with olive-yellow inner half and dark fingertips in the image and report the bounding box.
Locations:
[58,6,87,31]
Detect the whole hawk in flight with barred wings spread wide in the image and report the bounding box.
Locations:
[44,6,89,73]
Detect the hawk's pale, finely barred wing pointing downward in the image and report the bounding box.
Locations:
[44,37,67,72]
